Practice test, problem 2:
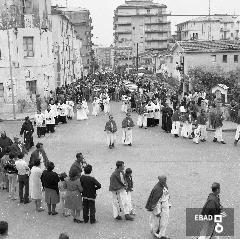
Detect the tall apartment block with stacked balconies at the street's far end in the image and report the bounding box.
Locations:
[114,0,171,66]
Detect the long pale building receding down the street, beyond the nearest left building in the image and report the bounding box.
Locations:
[51,7,83,86]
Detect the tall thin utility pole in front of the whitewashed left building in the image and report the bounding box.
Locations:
[5,0,16,120]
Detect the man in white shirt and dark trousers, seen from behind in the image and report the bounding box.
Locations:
[15,154,30,204]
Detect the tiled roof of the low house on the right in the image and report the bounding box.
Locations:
[173,41,240,52]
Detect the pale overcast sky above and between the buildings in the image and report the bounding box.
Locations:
[52,0,240,46]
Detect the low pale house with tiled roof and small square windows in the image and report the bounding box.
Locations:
[164,41,240,78]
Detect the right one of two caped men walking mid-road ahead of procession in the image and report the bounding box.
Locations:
[122,113,135,146]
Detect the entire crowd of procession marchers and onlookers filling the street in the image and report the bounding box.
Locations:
[0,74,236,239]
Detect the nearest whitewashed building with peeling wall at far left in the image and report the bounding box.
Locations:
[0,0,55,112]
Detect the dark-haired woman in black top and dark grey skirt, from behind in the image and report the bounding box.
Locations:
[41,162,60,215]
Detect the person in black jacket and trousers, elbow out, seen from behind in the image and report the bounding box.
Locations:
[80,165,101,224]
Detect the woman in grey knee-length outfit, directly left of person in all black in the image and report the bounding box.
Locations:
[64,170,83,223]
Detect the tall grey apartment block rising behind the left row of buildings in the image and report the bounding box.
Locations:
[62,7,94,75]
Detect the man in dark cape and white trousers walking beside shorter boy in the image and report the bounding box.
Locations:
[109,161,133,221]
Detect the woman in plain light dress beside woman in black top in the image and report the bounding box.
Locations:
[29,159,44,212]
